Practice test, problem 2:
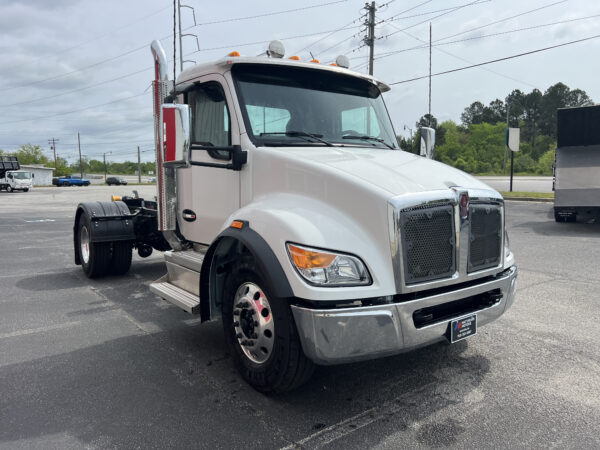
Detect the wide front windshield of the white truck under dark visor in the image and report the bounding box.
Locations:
[232,64,397,148]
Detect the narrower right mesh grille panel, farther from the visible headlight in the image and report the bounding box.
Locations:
[468,204,502,272]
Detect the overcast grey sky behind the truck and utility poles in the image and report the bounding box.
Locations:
[0,0,600,162]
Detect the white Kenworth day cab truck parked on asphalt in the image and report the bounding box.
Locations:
[73,41,517,393]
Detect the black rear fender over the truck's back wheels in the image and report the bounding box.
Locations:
[73,201,136,265]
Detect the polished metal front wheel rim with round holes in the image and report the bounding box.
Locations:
[233,283,275,364]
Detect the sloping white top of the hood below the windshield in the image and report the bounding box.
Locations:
[274,147,491,195]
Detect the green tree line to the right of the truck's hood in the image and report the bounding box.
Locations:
[398,83,594,175]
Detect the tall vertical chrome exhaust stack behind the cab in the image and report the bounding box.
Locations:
[150,40,183,250]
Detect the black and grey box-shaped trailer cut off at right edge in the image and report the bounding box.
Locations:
[553,106,600,222]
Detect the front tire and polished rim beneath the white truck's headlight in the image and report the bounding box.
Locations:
[223,257,314,394]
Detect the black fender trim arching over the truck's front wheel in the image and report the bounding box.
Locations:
[200,221,294,322]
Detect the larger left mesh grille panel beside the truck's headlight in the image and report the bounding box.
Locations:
[400,204,456,284]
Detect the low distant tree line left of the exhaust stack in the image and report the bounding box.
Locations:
[0,144,156,176]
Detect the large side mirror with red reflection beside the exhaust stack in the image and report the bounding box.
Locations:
[161,103,191,167]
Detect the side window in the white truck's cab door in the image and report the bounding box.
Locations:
[188,82,231,159]
